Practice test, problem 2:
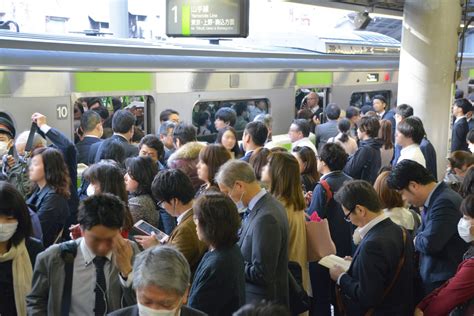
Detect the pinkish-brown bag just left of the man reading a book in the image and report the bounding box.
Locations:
[305,212,336,262]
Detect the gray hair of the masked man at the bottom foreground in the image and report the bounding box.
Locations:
[133,246,191,296]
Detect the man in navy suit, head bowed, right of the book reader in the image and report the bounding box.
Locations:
[387,160,468,295]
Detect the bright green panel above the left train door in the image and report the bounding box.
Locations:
[74,72,153,92]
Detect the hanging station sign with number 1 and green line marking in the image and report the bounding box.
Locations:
[166,0,249,38]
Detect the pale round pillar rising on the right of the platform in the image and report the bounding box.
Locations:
[398,0,461,179]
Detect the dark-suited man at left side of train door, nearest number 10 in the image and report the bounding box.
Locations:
[76,111,104,165]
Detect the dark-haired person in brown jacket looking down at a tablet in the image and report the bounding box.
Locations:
[135,169,207,273]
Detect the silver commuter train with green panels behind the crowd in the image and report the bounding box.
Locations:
[0,31,474,149]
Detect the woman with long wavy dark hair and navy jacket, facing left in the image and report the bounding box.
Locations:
[27,147,71,247]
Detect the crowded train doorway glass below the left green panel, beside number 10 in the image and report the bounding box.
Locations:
[74,95,154,143]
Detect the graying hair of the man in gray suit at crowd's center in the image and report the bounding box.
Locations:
[215,160,257,188]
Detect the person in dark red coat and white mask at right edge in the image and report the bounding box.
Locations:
[415,194,474,316]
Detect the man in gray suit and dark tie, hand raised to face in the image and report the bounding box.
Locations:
[26,193,138,316]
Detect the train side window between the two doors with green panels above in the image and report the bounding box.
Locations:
[193,98,270,142]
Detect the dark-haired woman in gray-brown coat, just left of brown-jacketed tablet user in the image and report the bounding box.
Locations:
[124,157,159,227]
